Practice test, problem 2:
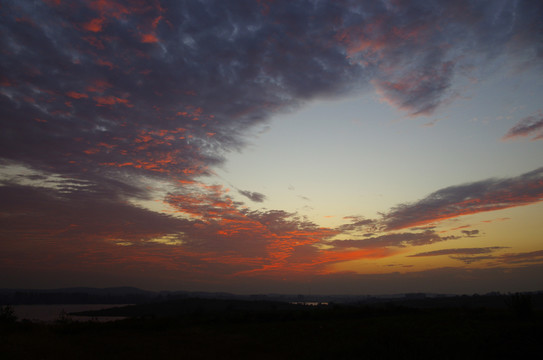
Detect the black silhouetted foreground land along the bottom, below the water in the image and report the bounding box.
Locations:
[0,298,543,359]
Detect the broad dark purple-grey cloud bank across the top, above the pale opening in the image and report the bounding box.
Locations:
[0,1,541,188]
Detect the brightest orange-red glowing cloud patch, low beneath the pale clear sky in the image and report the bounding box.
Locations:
[162,185,362,275]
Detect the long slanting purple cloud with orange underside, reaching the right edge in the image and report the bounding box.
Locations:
[383,168,543,230]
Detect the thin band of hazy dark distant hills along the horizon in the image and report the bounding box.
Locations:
[0,287,543,309]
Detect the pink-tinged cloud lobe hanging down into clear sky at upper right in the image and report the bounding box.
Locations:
[336,10,455,116]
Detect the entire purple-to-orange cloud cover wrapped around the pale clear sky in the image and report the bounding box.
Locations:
[0,0,543,286]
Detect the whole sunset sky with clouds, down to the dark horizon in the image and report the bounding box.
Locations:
[0,0,543,295]
